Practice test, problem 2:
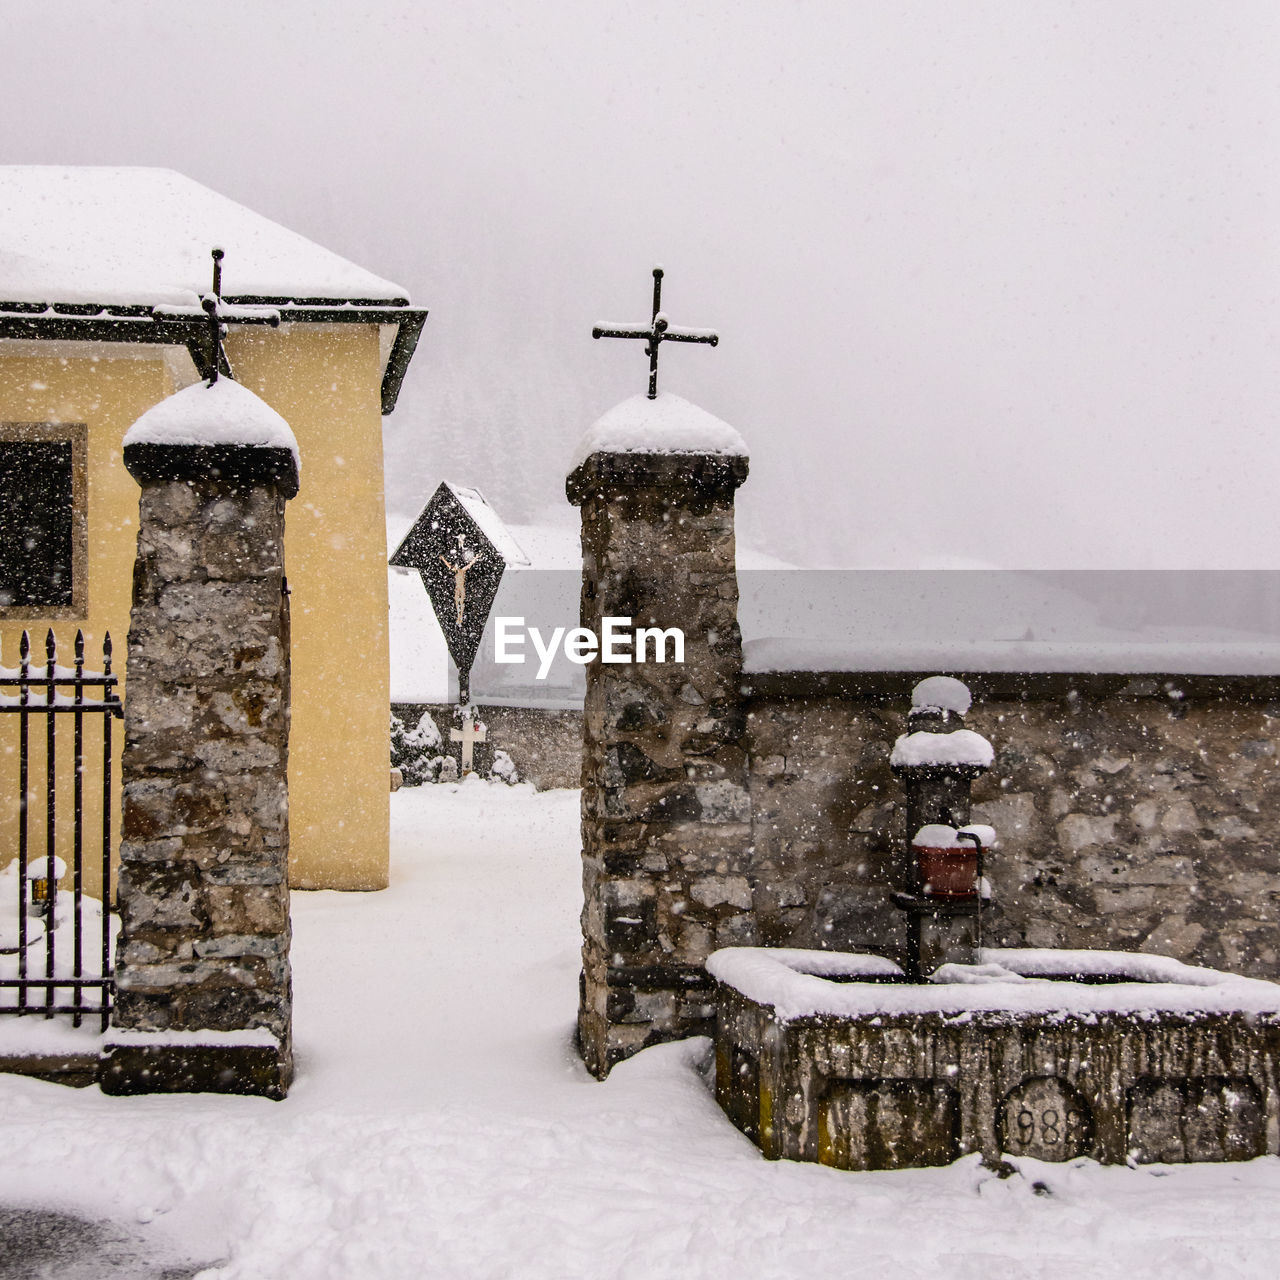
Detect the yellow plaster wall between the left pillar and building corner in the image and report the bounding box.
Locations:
[227,325,390,890]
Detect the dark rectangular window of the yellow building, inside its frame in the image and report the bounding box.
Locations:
[0,439,76,608]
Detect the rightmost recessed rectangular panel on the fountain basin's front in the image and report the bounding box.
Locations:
[1129,1075,1266,1164]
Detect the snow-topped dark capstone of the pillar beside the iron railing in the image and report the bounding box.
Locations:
[124,376,298,498]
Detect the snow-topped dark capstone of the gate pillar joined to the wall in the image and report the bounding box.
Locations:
[566,392,748,504]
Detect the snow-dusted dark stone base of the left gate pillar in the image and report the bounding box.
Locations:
[99,1030,293,1101]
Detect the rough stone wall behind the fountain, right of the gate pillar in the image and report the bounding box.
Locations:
[748,673,1280,978]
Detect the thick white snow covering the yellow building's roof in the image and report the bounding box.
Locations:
[0,165,407,306]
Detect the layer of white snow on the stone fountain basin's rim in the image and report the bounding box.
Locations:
[707,947,1280,1021]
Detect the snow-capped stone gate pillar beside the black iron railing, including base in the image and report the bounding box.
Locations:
[101,378,298,1097]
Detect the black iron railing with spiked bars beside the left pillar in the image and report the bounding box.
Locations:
[0,631,124,1030]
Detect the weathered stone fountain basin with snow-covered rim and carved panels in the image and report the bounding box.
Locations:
[707,947,1280,1169]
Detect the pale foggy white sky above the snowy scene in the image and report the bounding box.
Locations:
[0,0,1280,567]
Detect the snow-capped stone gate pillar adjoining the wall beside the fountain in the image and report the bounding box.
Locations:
[567,396,756,1076]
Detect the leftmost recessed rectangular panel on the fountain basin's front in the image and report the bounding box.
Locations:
[818,1080,960,1169]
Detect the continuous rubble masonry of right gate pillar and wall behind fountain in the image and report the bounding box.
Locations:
[568,432,1280,1075]
